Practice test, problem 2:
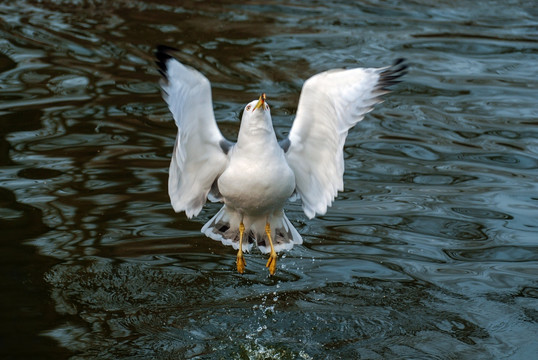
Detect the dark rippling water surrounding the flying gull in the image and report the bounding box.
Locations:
[0,0,538,359]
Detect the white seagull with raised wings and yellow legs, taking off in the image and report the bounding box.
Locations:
[155,45,407,275]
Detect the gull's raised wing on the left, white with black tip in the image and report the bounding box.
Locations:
[155,46,232,218]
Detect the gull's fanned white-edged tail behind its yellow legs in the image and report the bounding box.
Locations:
[202,205,303,254]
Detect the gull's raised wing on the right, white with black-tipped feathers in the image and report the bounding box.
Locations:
[281,59,407,218]
